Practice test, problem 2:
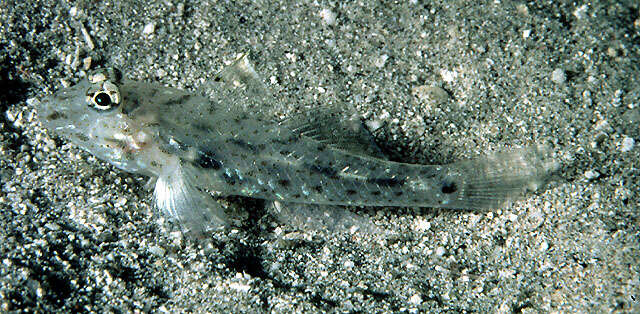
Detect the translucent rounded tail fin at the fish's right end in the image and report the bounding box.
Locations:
[442,146,559,209]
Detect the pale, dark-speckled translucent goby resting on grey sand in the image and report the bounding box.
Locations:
[37,54,557,233]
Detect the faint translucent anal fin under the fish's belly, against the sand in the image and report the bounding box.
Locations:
[269,201,383,235]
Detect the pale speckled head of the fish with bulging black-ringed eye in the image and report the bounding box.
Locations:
[37,68,148,172]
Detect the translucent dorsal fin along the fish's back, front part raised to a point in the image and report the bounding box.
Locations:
[201,53,386,159]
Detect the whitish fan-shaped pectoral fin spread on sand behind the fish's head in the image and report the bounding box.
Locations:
[153,164,227,235]
